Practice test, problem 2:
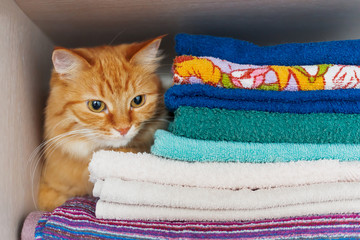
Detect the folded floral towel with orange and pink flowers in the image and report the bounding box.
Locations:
[173,56,360,91]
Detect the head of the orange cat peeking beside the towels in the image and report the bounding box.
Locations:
[45,36,165,155]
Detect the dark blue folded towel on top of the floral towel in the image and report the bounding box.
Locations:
[175,34,360,66]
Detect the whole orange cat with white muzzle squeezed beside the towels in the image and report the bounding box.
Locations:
[38,36,166,211]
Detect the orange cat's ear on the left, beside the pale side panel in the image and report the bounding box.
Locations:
[52,48,90,74]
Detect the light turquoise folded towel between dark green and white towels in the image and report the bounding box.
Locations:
[151,130,360,163]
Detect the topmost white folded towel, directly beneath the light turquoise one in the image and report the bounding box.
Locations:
[89,150,360,189]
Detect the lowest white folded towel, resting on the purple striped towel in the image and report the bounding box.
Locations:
[95,200,360,221]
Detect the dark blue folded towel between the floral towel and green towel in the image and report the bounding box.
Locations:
[165,84,360,114]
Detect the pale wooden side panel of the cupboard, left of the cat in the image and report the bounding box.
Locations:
[0,0,52,239]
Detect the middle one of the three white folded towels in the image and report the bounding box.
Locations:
[94,178,360,210]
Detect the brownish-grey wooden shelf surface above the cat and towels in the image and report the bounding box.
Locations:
[16,0,360,49]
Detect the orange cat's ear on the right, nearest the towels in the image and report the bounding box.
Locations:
[130,35,166,68]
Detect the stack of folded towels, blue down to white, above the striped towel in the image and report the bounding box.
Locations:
[89,34,360,221]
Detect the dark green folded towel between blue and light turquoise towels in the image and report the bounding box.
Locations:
[169,107,360,144]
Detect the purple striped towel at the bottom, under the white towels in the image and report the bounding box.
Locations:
[36,197,360,240]
